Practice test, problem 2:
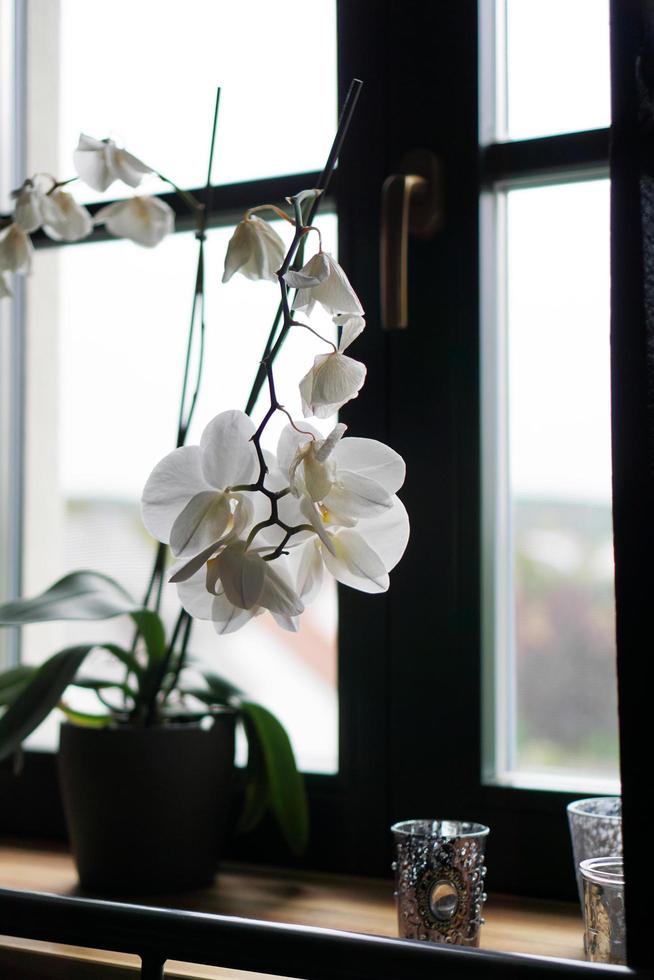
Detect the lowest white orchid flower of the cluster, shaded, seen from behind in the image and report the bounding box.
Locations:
[171,540,304,633]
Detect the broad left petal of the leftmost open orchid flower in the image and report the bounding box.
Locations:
[141,446,212,544]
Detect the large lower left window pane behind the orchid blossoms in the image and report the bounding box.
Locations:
[24,215,338,772]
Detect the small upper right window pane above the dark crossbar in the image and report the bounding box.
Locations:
[498,0,610,139]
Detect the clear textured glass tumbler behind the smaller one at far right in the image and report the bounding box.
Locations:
[568,796,622,911]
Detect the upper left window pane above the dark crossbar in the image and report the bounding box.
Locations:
[29,0,336,200]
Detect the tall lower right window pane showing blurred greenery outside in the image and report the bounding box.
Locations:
[500,180,618,785]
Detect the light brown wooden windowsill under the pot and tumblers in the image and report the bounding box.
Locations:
[0,843,583,978]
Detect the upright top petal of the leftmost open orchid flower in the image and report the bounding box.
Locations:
[200,409,258,490]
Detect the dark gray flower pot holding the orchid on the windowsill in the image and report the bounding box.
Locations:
[58,711,235,894]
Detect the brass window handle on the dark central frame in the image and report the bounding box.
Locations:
[379,150,443,330]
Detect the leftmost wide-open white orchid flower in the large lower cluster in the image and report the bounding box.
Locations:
[141,411,262,568]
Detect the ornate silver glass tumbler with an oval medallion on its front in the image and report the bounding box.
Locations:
[391,820,488,946]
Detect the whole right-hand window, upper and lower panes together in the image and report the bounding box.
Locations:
[481,0,619,794]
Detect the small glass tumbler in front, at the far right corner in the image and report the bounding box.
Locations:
[581,857,627,963]
